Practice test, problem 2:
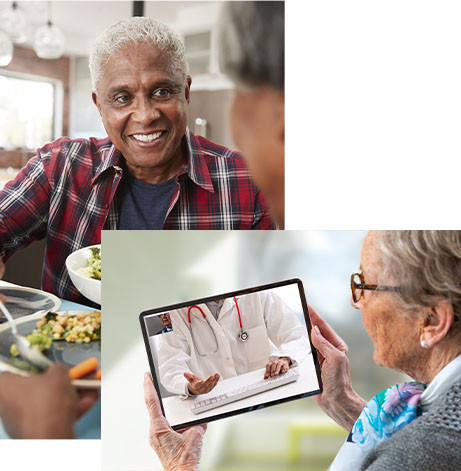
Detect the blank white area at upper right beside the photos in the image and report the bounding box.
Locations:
[286,0,461,229]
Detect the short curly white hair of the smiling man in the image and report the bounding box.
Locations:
[89,17,187,91]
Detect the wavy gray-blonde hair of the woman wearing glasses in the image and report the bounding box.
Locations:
[378,231,461,317]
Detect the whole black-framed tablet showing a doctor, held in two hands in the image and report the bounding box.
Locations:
[140,279,322,430]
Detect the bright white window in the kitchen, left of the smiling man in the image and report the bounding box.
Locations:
[0,75,59,150]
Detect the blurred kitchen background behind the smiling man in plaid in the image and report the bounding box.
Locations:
[0,1,236,288]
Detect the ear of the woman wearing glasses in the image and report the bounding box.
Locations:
[420,299,455,348]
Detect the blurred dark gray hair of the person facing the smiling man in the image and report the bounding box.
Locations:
[219,1,285,91]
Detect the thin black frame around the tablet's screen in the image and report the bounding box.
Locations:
[139,278,323,430]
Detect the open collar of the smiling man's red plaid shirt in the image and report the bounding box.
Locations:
[91,128,214,193]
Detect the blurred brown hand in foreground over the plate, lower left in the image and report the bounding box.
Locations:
[0,363,99,438]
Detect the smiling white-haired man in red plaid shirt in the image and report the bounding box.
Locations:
[0,18,273,301]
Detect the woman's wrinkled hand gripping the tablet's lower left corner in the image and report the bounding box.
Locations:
[144,373,206,471]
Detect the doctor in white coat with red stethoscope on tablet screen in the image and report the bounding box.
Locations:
[158,291,310,396]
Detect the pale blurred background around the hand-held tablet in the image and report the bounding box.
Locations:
[102,231,403,471]
